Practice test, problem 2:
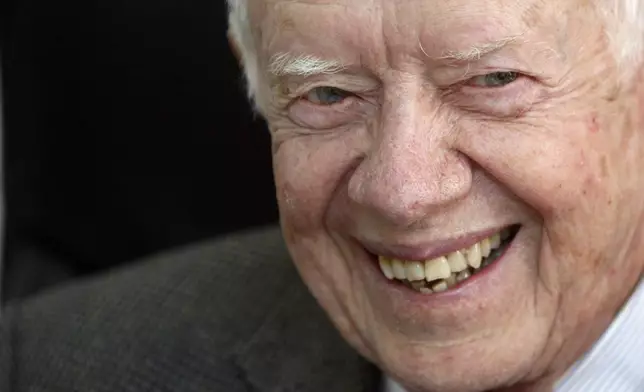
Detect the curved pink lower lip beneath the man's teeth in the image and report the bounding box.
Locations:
[365,230,521,303]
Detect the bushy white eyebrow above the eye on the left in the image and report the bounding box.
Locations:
[268,53,345,77]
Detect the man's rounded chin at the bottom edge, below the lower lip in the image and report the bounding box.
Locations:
[376,330,547,392]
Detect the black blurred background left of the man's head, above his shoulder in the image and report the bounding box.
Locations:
[0,0,277,301]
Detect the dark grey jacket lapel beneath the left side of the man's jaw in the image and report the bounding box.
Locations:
[236,278,380,392]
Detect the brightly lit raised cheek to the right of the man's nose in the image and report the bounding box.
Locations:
[478,108,619,220]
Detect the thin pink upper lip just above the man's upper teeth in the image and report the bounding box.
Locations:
[360,226,510,261]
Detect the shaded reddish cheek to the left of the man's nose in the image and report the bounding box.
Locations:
[273,136,356,234]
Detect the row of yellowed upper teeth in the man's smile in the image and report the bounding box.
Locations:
[378,233,501,282]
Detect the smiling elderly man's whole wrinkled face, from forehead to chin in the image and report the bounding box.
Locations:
[244,0,644,391]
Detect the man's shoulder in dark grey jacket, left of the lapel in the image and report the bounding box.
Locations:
[0,227,306,391]
